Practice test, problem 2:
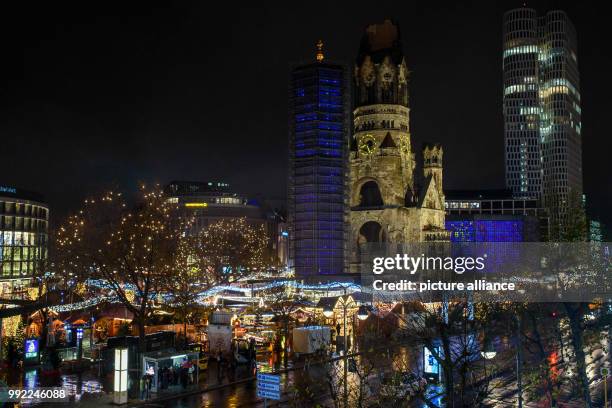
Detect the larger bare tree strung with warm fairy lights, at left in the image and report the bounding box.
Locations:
[57,187,188,351]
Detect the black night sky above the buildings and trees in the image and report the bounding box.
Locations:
[0,0,612,233]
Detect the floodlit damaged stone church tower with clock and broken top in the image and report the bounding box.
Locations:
[349,20,448,272]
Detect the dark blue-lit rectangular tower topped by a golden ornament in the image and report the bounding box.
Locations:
[288,42,349,276]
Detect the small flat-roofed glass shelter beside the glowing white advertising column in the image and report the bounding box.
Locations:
[141,349,200,392]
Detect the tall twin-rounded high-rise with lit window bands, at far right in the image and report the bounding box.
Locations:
[503,8,582,226]
